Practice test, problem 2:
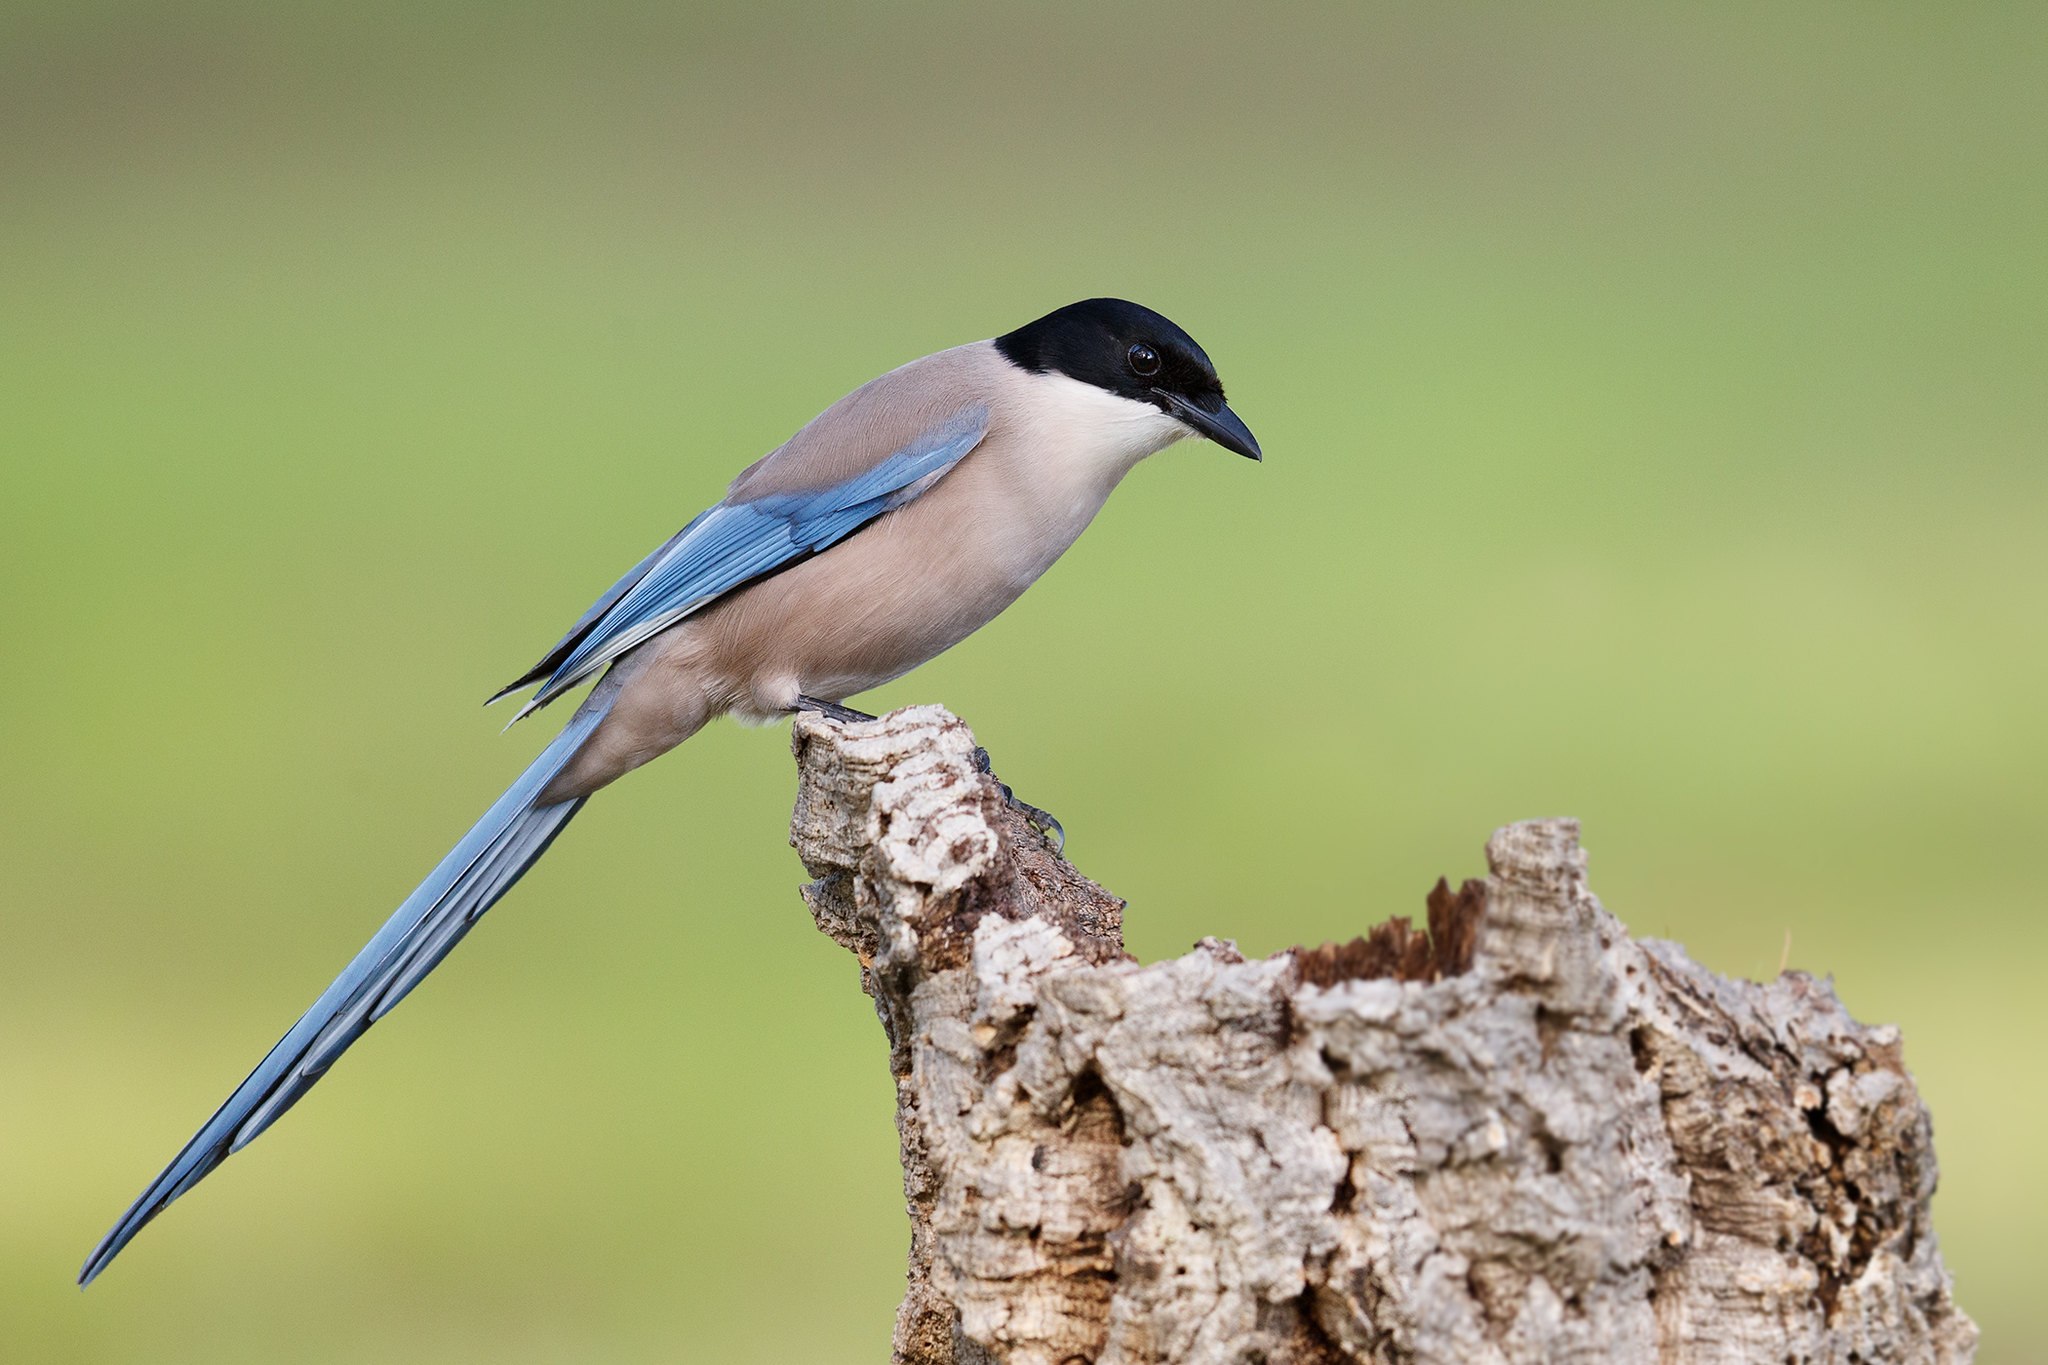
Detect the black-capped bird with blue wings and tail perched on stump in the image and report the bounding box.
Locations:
[78,299,1264,1285]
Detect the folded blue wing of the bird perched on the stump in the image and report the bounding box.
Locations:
[514,405,989,716]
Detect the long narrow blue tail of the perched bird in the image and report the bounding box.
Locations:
[78,679,616,1285]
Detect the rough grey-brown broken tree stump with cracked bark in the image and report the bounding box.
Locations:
[793,706,1976,1365]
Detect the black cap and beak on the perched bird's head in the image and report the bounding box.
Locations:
[995,299,1260,460]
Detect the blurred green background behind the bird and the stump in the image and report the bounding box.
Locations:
[0,0,2048,1363]
